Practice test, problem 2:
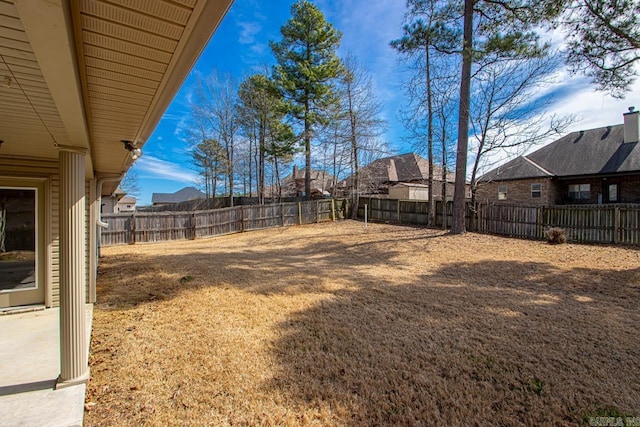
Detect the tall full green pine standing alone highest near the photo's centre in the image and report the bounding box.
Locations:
[271,0,342,199]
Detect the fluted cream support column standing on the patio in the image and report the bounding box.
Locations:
[56,146,89,388]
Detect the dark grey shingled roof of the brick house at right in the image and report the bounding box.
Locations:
[479,125,640,182]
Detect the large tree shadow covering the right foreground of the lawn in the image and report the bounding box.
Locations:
[255,261,640,426]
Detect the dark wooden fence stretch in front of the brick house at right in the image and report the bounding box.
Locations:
[478,204,640,245]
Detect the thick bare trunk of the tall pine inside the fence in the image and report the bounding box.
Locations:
[451,0,473,234]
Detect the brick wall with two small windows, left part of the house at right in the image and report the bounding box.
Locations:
[476,178,558,206]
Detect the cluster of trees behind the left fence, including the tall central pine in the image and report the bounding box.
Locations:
[182,1,385,212]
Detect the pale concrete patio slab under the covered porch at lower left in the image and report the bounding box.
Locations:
[0,304,93,427]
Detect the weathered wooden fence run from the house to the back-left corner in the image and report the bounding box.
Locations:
[101,199,350,246]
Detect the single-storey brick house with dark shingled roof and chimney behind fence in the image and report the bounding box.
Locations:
[476,107,640,206]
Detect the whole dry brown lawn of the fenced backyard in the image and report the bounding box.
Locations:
[85,221,640,426]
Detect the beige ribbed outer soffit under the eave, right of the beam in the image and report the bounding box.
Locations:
[72,0,232,177]
